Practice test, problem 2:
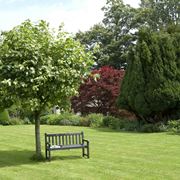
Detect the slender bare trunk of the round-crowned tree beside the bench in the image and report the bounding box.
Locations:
[35,111,42,159]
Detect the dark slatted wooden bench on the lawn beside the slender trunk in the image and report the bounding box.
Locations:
[45,132,89,160]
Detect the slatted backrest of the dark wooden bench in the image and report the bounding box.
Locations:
[45,132,84,145]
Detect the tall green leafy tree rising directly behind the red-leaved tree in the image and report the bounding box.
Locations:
[76,0,136,69]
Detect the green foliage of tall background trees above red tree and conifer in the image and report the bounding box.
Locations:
[76,0,180,69]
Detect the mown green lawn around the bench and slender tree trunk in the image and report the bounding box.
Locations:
[0,125,180,180]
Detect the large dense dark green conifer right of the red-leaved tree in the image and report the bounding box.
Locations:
[118,26,180,122]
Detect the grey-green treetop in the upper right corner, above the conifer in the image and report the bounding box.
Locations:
[139,0,180,30]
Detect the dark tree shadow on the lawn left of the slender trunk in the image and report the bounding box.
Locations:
[0,150,37,168]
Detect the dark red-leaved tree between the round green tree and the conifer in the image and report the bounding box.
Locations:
[71,66,125,115]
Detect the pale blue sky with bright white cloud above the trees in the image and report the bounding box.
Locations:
[0,0,140,33]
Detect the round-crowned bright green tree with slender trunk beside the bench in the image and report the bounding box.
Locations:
[0,20,92,158]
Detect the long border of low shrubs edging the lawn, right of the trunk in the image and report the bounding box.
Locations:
[40,112,174,133]
